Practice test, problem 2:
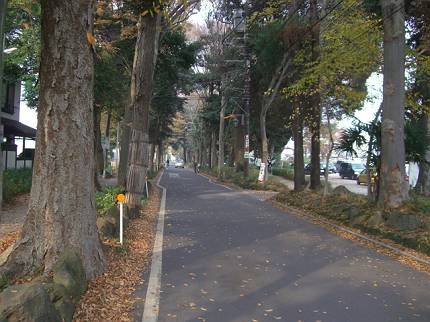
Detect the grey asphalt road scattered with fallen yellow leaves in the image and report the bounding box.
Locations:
[141,169,430,322]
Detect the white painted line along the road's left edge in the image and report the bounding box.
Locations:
[142,173,167,322]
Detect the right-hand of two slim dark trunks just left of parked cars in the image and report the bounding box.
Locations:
[309,0,321,190]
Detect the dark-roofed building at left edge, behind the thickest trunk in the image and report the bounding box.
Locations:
[0,82,36,170]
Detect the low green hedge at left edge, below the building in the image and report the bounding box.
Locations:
[3,168,33,202]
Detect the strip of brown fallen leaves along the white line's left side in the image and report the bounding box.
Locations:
[73,186,160,322]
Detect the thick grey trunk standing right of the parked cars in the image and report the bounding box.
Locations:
[378,0,409,208]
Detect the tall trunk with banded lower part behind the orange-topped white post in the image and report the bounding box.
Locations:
[126,13,160,216]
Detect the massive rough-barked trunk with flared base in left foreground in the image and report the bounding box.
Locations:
[2,0,104,278]
